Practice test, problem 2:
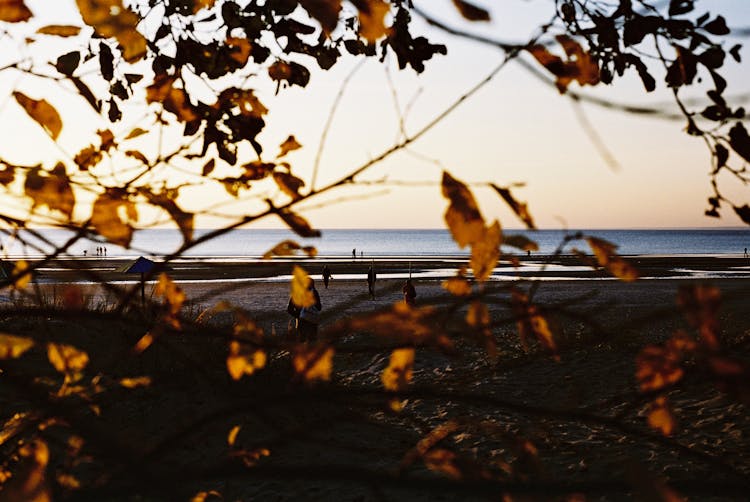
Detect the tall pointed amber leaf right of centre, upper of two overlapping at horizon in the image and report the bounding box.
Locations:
[442,171,485,247]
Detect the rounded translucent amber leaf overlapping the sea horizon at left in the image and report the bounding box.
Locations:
[91,188,138,247]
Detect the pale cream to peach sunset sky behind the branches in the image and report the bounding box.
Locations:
[0,0,750,229]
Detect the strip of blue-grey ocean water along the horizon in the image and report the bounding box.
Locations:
[0,228,750,259]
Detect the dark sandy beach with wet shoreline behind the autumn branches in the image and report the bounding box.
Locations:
[4,256,750,500]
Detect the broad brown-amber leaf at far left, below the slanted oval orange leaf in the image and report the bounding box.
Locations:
[24,162,75,219]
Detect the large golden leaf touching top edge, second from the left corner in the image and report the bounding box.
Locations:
[76,0,146,63]
